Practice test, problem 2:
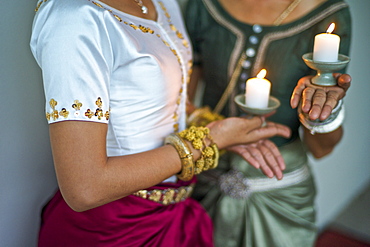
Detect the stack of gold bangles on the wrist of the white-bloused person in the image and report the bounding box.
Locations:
[165,126,219,181]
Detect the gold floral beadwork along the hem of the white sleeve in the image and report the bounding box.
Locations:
[46,97,110,121]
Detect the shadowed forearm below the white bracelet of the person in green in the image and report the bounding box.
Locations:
[303,127,343,158]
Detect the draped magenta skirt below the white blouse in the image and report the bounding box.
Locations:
[38,178,213,247]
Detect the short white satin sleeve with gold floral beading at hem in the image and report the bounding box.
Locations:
[30,1,112,123]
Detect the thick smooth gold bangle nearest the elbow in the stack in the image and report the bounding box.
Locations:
[164,133,195,181]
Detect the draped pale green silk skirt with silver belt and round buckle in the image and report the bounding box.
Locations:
[193,140,317,247]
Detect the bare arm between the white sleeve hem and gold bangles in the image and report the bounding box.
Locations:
[50,121,185,211]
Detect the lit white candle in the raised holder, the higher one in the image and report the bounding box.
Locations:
[313,23,340,62]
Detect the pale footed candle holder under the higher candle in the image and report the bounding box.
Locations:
[302,53,350,86]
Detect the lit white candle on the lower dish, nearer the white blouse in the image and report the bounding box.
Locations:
[245,69,271,108]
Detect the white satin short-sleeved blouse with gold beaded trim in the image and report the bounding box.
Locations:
[31,0,192,161]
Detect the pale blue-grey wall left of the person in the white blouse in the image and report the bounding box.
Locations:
[0,0,56,247]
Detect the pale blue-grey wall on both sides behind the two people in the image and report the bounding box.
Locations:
[0,0,370,247]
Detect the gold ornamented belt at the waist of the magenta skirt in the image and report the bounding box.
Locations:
[132,184,194,205]
